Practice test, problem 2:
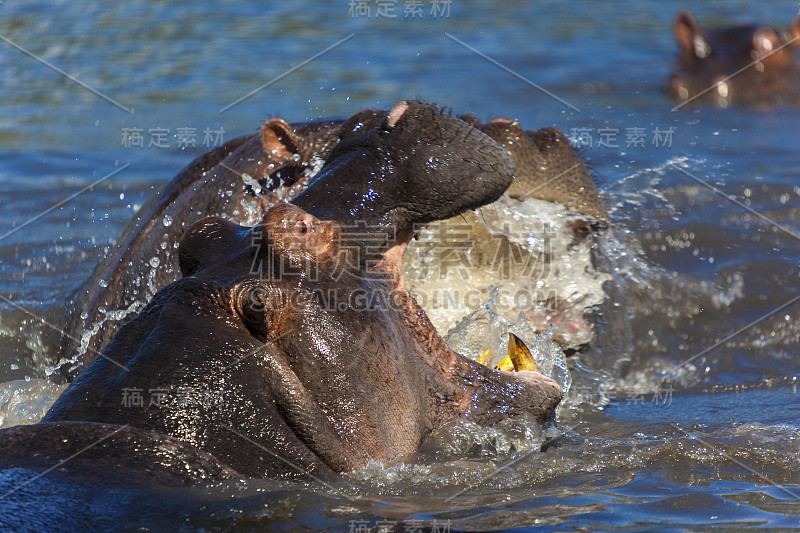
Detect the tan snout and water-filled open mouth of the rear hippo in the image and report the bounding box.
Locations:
[404,115,609,351]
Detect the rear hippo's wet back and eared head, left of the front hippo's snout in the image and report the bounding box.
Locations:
[62,118,342,374]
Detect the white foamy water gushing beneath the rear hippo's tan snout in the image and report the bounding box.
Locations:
[403,196,609,348]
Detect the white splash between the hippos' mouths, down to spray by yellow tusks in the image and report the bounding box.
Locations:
[403,192,625,412]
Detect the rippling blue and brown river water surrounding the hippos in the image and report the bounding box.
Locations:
[0,0,800,531]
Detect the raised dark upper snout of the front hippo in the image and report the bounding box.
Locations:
[292,101,513,262]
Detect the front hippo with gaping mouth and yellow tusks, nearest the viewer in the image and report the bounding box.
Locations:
[0,101,562,485]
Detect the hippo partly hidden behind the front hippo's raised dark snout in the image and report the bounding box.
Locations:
[62,104,608,381]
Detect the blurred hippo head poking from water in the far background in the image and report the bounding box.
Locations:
[664,9,800,108]
